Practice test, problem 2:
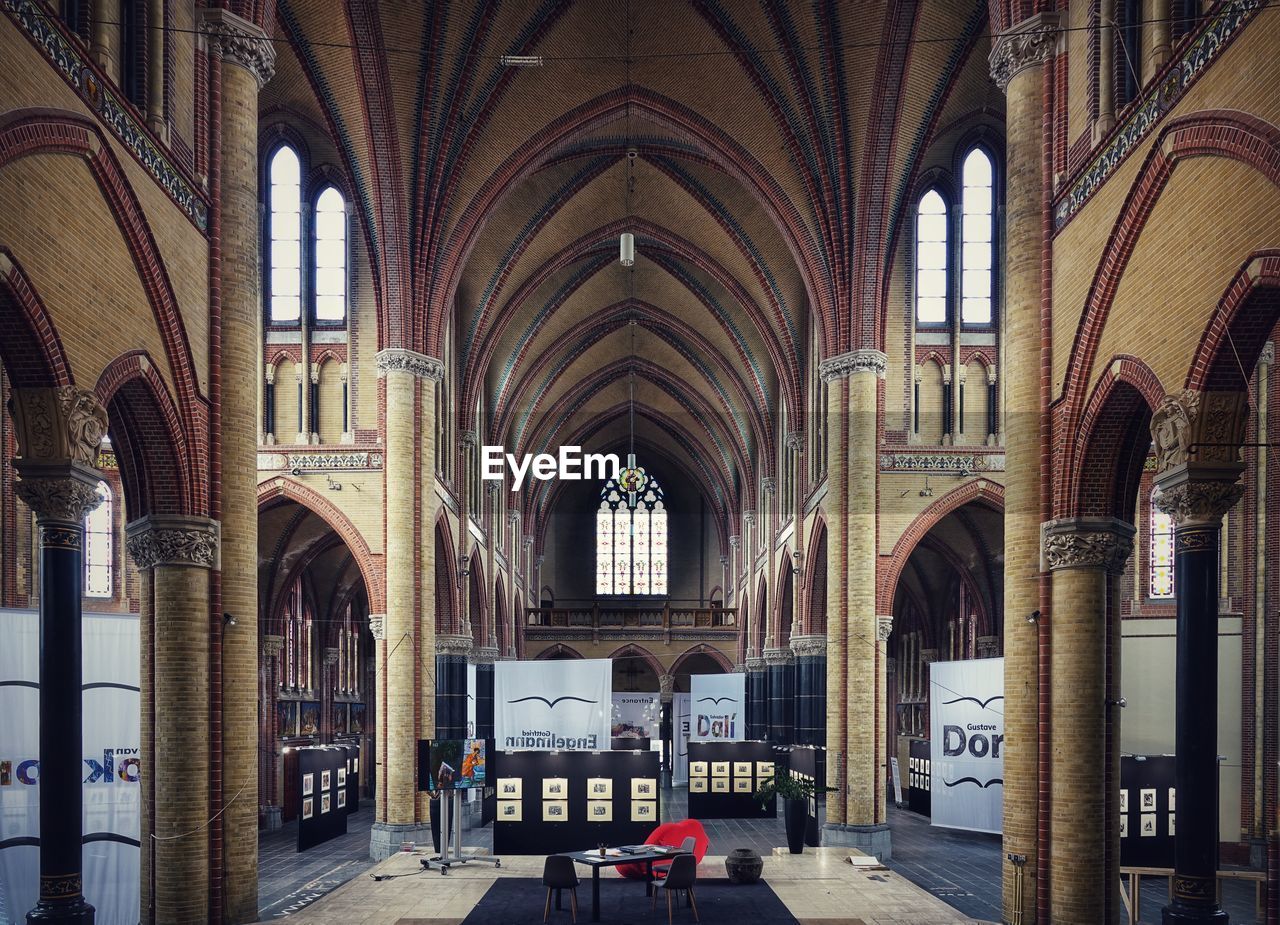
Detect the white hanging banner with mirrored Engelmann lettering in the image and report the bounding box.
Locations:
[493,659,613,751]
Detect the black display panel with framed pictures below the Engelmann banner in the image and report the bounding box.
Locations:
[489,751,662,855]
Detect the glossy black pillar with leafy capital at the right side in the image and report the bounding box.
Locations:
[1156,472,1242,925]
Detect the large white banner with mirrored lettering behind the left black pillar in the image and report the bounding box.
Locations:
[0,610,138,925]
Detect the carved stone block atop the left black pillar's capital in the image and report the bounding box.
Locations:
[9,385,108,468]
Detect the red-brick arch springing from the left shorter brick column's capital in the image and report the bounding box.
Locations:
[95,351,192,519]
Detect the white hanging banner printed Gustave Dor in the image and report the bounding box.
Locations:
[929,659,1005,834]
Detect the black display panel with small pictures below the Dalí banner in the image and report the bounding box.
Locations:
[689,742,787,819]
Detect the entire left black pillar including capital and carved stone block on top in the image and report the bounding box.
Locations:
[10,385,106,925]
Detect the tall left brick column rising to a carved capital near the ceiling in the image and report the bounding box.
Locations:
[199,9,275,922]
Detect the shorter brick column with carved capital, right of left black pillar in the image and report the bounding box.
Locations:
[125,514,218,922]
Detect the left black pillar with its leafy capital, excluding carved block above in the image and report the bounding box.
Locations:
[18,463,100,925]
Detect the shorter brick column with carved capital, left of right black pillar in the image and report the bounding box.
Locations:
[1044,518,1134,925]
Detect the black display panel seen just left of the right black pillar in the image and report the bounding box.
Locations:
[1117,755,1178,867]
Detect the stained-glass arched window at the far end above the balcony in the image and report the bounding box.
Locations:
[595,476,667,594]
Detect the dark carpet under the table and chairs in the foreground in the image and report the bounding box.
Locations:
[462,876,799,925]
